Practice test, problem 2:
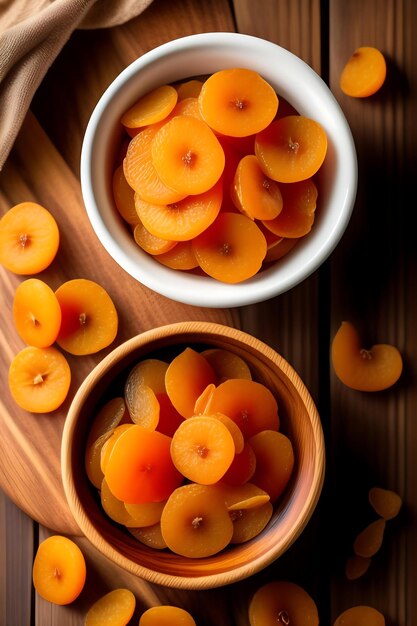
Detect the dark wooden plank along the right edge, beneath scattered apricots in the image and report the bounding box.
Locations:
[329,0,417,626]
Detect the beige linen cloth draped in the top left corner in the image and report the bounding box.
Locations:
[0,0,152,169]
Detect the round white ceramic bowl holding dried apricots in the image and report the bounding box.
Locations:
[81,33,357,307]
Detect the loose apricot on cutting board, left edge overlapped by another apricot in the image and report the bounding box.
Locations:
[55,278,118,355]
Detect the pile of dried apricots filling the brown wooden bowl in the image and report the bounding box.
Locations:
[85,347,294,558]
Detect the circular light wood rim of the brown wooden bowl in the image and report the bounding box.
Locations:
[61,321,326,589]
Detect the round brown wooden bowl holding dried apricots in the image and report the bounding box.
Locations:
[61,322,325,589]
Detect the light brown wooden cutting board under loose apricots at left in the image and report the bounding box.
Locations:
[0,114,237,533]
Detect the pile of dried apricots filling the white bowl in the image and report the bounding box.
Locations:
[113,68,327,283]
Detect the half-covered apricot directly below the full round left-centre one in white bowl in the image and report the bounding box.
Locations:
[135,183,223,242]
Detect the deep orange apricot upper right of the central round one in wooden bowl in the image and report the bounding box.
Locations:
[207,378,279,438]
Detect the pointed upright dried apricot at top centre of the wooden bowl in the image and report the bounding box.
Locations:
[165,347,216,417]
